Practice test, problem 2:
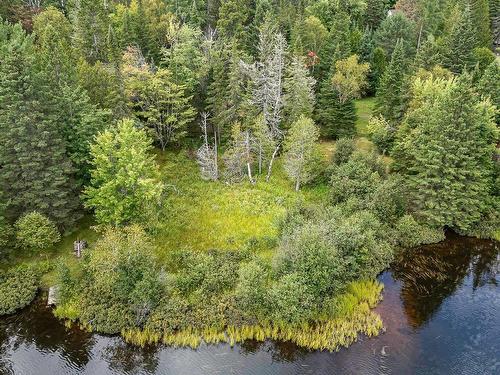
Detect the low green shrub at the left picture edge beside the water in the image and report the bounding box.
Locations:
[0,265,38,315]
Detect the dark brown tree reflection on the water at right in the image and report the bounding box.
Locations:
[392,235,499,328]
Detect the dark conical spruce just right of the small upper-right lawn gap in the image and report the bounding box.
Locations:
[375,40,408,125]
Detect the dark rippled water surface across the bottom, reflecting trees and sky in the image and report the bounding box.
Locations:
[0,237,500,375]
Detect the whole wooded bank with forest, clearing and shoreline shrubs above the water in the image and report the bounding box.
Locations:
[0,0,500,350]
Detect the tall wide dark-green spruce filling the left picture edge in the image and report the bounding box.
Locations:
[0,24,79,228]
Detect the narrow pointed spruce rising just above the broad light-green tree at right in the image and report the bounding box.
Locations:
[444,5,477,74]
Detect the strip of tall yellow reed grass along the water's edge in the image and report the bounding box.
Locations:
[122,281,383,351]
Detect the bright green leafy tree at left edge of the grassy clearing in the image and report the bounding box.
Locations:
[84,119,163,226]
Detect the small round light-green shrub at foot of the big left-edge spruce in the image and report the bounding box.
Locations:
[14,211,61,251]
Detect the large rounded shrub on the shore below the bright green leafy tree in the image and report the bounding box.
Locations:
[63,226,162,334]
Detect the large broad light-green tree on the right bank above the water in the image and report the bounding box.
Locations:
[393,76,497,231]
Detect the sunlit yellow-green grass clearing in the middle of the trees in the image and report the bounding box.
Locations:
[152,151,325,257]
